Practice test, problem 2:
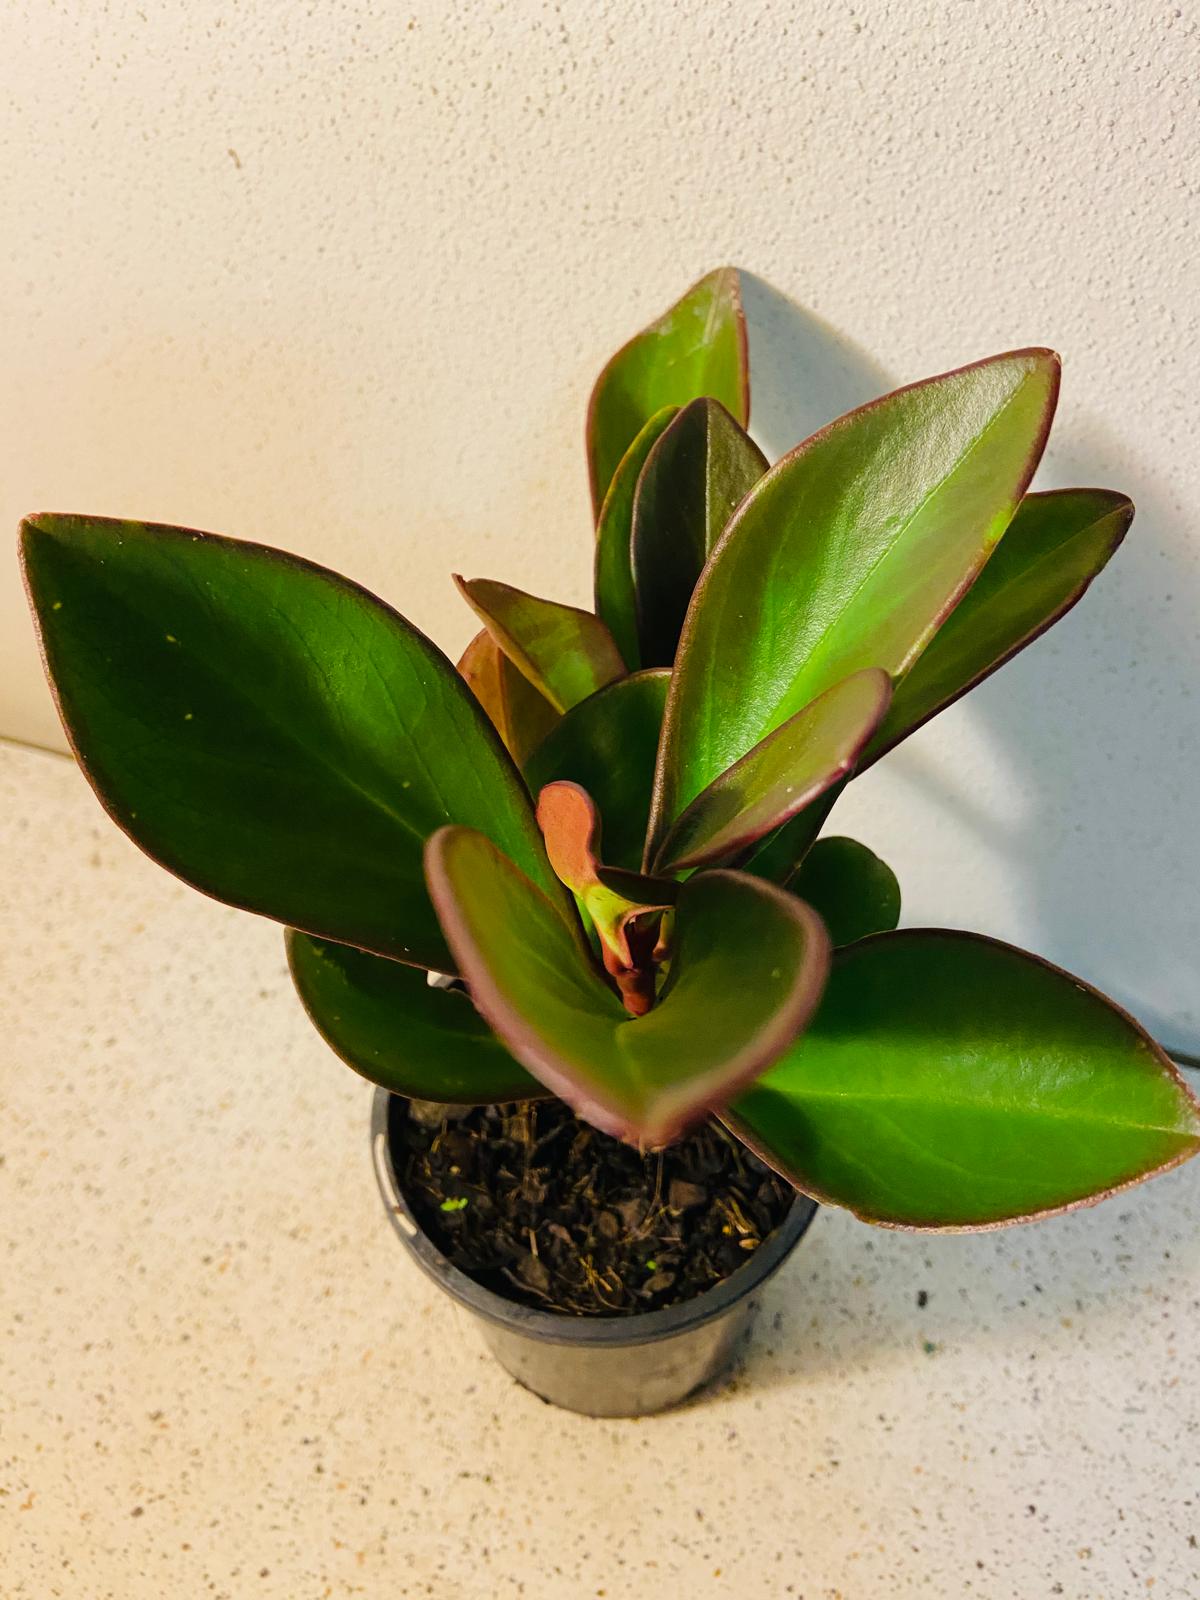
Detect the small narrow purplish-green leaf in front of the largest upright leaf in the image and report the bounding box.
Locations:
[651,667,891,872]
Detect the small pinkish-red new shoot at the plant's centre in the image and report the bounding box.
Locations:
[538,782,678,1016]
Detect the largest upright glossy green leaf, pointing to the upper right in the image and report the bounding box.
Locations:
[651,350,1058,846]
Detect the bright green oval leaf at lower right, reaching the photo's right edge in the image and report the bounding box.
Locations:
[730,930,1200,1229]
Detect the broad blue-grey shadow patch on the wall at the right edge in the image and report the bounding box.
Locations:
[966,444,1200,1056]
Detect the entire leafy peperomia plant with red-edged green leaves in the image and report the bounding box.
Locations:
[22,269,1200,1229]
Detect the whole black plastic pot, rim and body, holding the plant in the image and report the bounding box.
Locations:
[371,1090,816,1416]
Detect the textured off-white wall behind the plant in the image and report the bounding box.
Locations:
[0,0,1200,1048]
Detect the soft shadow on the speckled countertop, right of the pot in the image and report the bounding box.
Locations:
[694,1162,1200,1403]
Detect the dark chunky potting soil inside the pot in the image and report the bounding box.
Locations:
[390,1099,795,1317]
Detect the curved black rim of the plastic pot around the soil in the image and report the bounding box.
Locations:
[371,1088,818,1347]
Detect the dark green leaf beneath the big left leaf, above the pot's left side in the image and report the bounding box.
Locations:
[286,930,546,1106]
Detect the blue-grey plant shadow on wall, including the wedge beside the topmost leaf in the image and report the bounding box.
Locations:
[742,274,1200,1056]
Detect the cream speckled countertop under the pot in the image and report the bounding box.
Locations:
[0,747,1200,1600]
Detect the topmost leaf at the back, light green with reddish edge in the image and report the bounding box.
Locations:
[587,267,750,512]
